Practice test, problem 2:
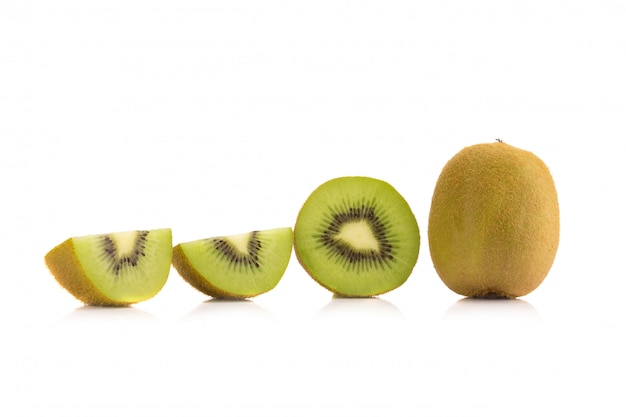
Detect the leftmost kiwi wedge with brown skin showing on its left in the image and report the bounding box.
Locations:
[45,229,172,306]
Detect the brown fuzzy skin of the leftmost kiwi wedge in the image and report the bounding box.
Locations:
[44,238,124,307]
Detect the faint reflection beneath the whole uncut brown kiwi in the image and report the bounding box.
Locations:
[443,297,541,321]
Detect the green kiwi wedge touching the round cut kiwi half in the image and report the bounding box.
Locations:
[172,227,293,299]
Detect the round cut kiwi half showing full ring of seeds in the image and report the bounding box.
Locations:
[294,177,420,297]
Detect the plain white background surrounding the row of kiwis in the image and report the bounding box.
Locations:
[0,0,626,416]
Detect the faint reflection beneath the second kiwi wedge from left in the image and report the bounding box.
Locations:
[184,298,274,321]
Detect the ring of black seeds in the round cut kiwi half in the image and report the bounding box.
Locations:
[316,203,393,269]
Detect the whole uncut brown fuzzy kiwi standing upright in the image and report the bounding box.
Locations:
[428,140,559,298]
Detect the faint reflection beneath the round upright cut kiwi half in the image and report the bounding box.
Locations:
[314,294,404,319]
